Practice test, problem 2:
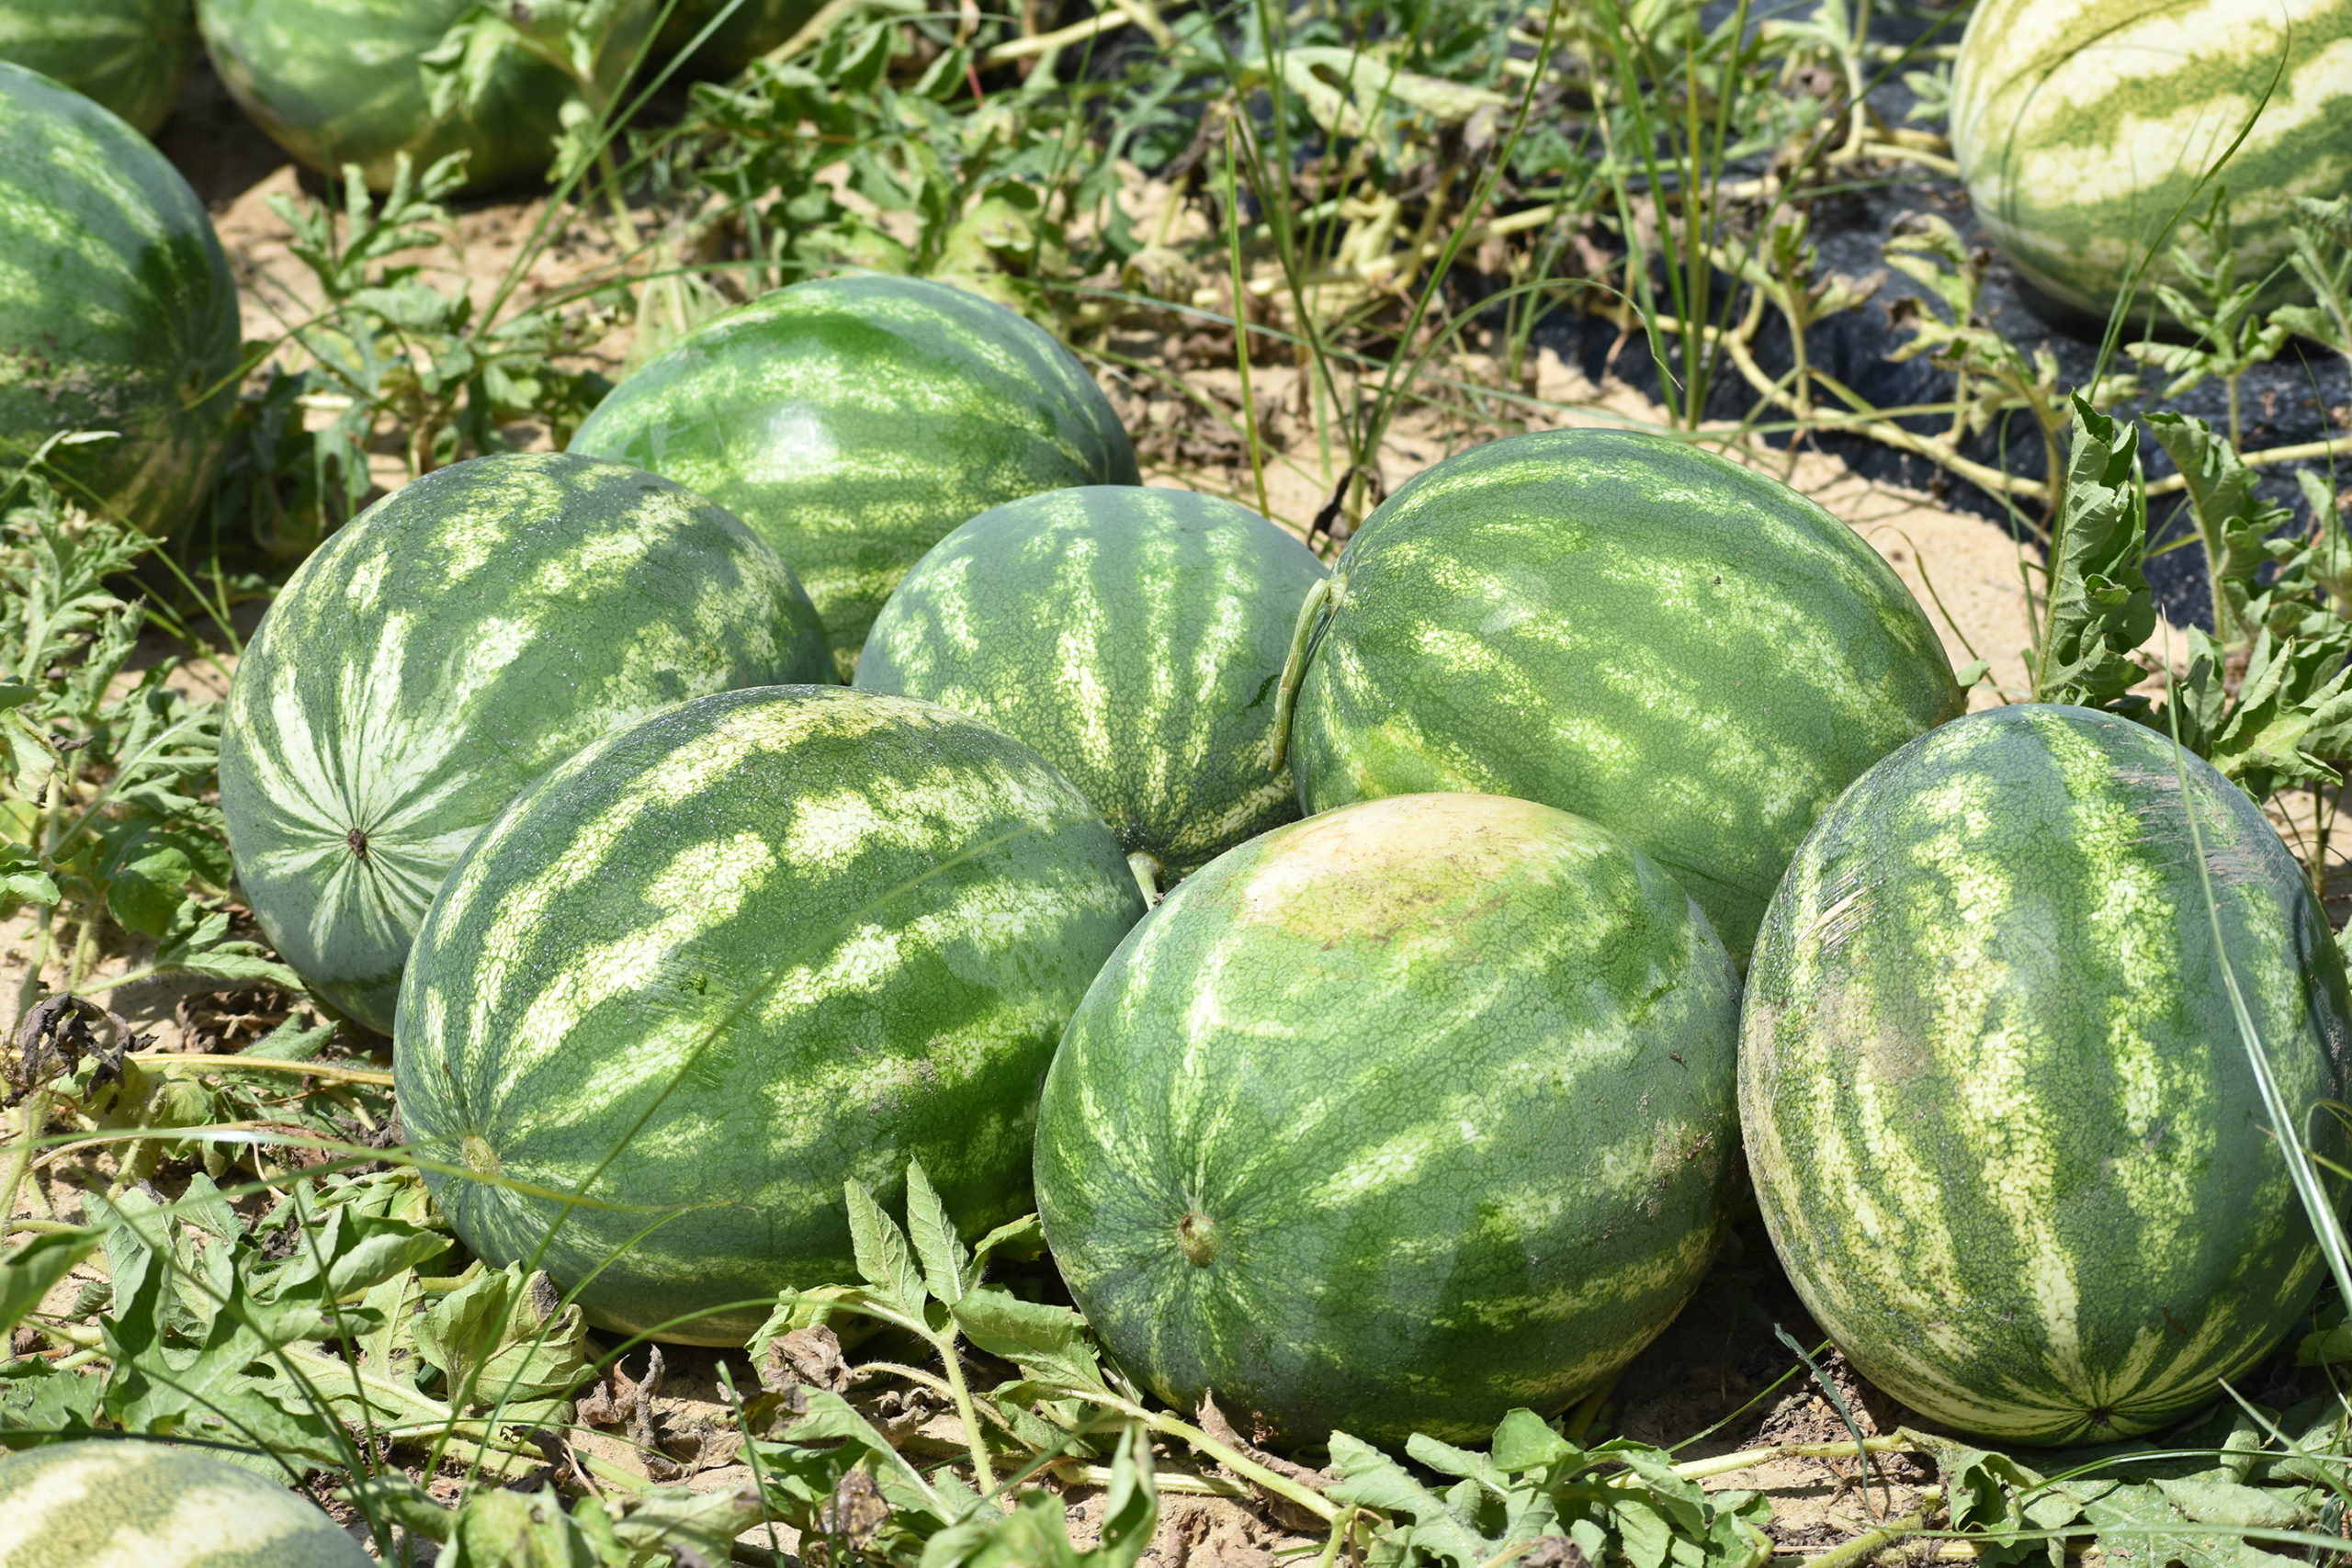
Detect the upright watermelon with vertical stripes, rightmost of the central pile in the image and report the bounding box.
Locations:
[1740,707,2352,1446]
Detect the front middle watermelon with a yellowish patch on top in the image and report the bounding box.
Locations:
[1037,795,1740,1446]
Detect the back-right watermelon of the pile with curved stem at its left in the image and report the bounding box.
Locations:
[1291,430,1962,962]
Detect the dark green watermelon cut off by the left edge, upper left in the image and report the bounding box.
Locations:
[0,62,238,531]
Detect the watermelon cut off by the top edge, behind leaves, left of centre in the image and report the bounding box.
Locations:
[198,0,659,190]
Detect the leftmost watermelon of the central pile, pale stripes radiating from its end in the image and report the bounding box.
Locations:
[221,451,832,1032]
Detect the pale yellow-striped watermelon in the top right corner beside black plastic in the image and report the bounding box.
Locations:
[1952,0,2352,317]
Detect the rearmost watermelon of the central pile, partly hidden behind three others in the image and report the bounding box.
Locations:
[571,277,1138,682]
